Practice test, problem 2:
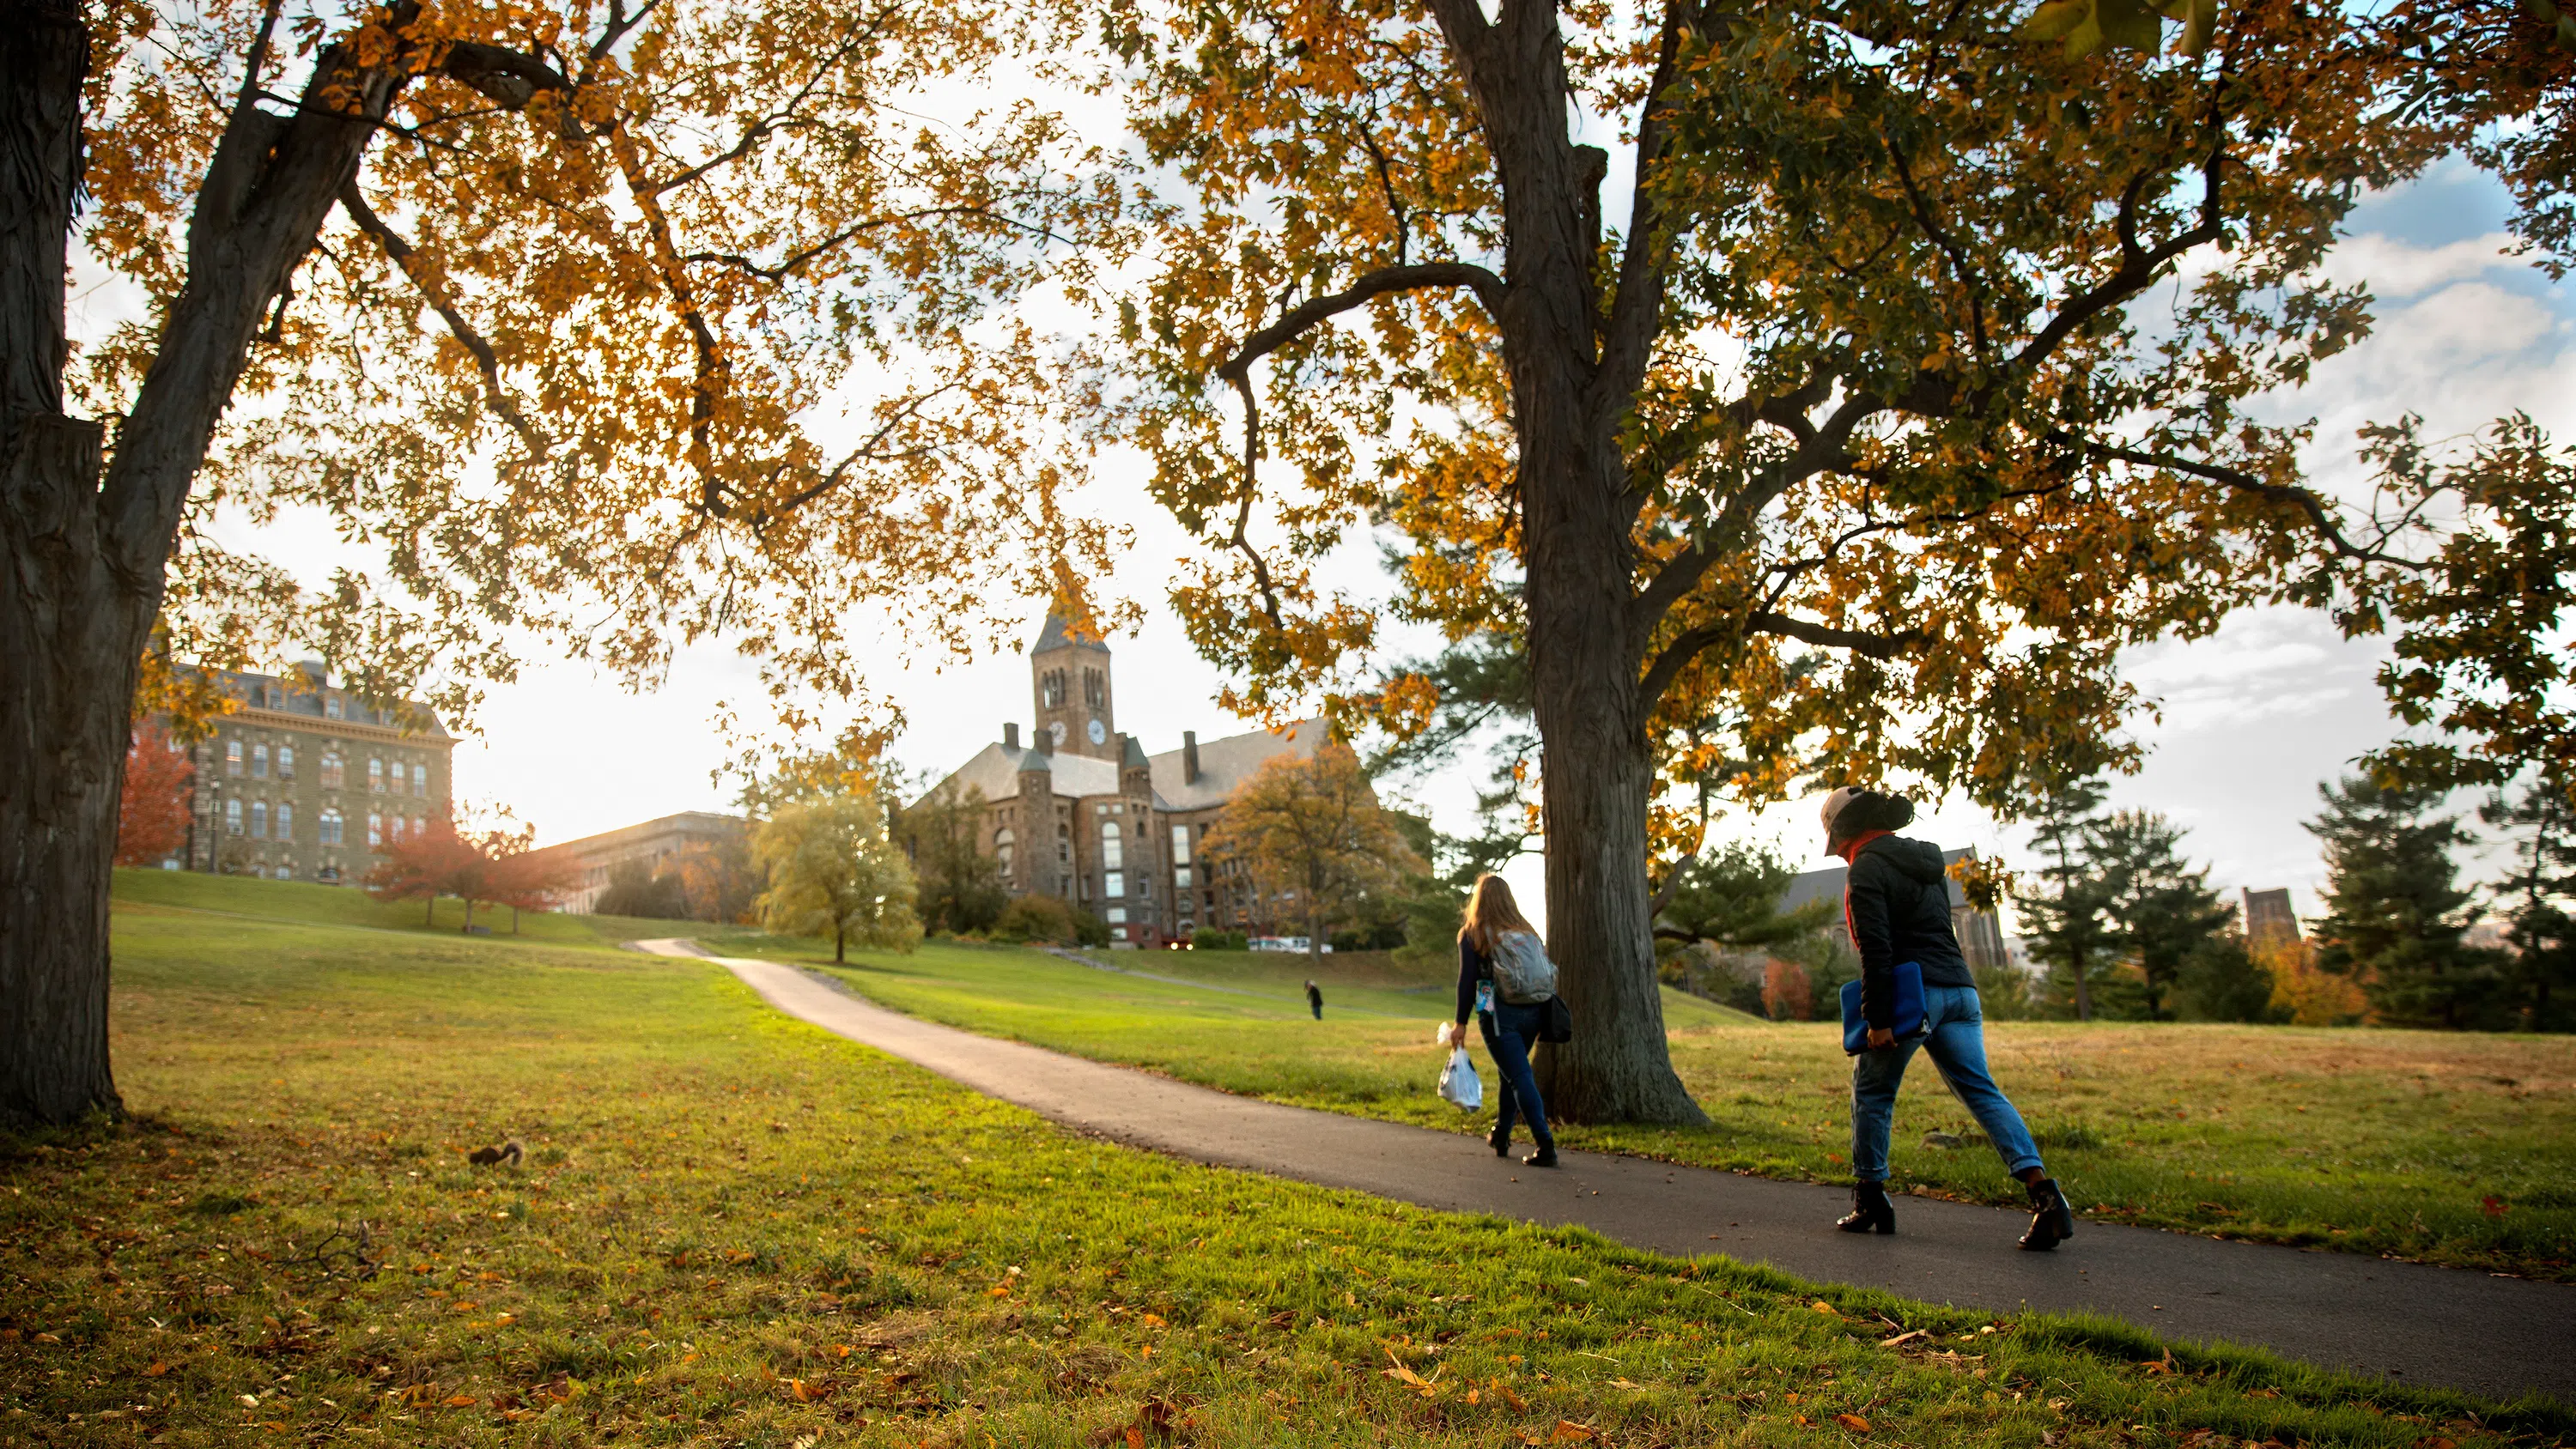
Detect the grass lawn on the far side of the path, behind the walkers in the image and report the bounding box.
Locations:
[724,937,2576,1282]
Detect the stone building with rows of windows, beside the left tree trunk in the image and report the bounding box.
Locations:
[173,662,456,885]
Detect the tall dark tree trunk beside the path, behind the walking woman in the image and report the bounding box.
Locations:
[1432,0,1708,1125]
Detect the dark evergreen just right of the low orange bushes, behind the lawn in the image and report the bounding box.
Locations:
[2308,777,2496,1029]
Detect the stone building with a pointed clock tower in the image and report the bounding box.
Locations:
[925,618,1324,947]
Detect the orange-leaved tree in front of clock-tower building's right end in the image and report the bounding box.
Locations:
[1200,743,1427,967]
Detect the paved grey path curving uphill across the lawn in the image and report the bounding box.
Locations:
[636,939,2576,1403]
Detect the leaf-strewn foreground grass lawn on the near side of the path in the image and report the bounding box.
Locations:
[0,880,2576,1449]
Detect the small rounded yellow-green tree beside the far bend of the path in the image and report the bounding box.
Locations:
[752,790,922,962]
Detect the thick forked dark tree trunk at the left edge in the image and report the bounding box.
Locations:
[0,0,404,1125]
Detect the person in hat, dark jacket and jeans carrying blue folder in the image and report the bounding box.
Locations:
[1824,785,2076,1251]
